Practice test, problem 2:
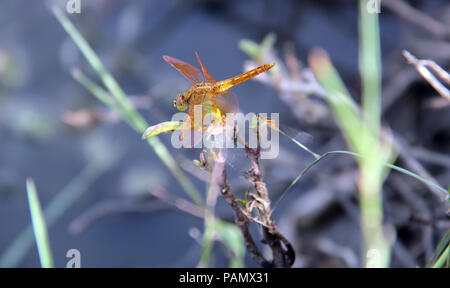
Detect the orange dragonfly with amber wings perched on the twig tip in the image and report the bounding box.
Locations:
[163,52,275,138]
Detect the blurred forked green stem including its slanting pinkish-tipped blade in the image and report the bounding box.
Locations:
[309,22,393,267]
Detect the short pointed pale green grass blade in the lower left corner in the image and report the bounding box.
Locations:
[27,179,53,268]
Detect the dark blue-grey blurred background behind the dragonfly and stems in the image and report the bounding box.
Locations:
[0,0,450,267]
